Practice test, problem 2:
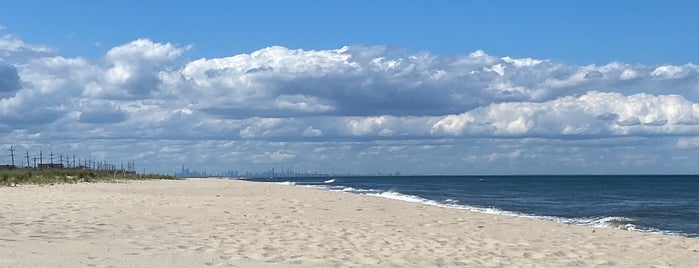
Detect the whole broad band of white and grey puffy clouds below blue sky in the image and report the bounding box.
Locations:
[4,35,699,139]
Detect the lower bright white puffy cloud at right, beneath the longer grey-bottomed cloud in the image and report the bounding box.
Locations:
[432,91,699,138]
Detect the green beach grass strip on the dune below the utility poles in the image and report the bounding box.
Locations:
[0,169,176,186]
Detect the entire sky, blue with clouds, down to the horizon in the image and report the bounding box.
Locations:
[0,0,699,174]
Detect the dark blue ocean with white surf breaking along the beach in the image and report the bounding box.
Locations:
[247,175,699,237]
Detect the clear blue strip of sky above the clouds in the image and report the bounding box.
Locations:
[5,0,699,64]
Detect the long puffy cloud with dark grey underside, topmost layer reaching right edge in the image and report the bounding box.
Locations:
[167,46,699,122]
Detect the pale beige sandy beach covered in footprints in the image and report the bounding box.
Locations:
[0,179,699,267]
